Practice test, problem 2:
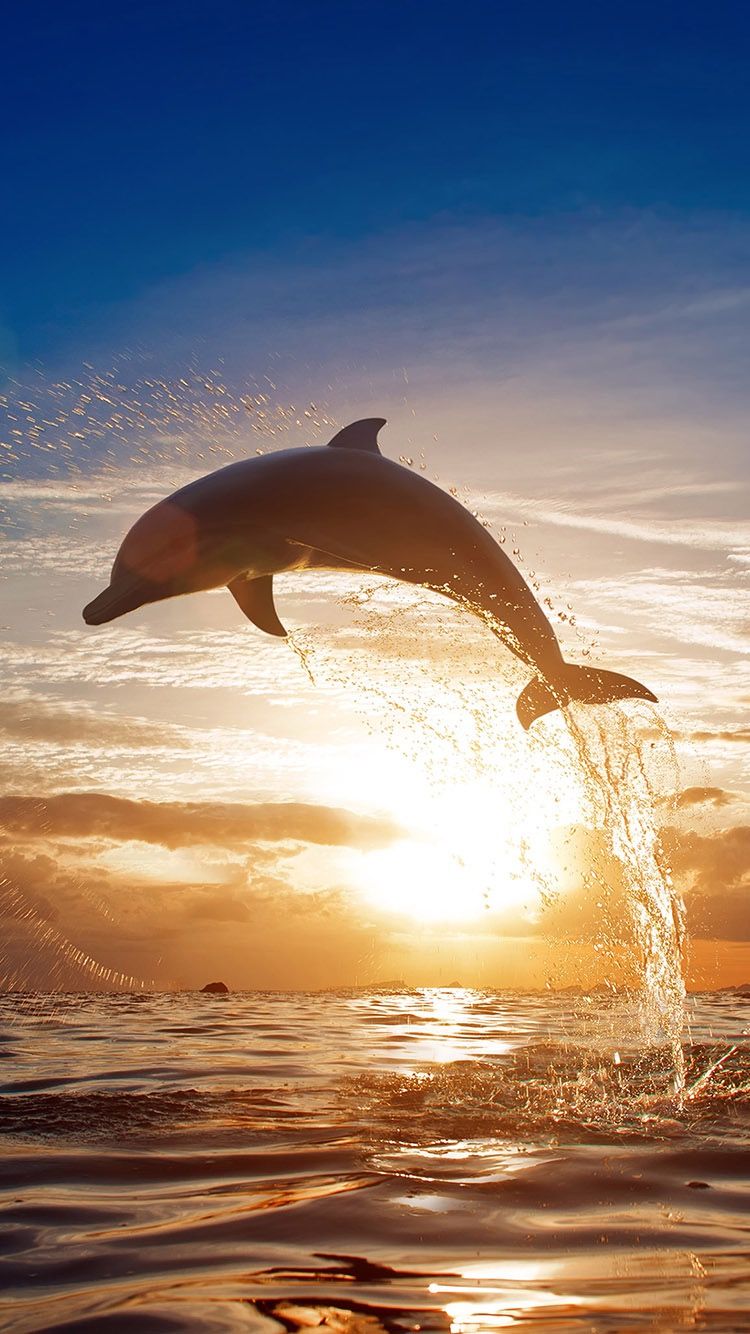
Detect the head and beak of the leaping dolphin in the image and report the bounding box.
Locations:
[83,498,242,626]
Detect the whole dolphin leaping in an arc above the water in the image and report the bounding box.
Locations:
[83,418,655,728]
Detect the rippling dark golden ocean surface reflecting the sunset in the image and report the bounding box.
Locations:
[0,988,750,1334]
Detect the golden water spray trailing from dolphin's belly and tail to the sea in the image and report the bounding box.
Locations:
[295,584,685,1101]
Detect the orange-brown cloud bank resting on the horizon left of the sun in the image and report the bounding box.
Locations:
[0,850,376,991]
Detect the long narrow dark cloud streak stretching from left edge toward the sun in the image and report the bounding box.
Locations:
[0,792,399,848]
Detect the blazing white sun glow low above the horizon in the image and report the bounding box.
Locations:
[344,693,582,927]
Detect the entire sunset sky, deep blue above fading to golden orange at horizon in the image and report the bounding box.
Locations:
[0,0,750,988]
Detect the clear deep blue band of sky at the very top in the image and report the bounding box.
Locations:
[0,0,750,367]
